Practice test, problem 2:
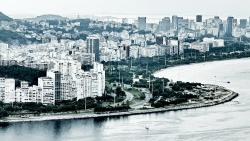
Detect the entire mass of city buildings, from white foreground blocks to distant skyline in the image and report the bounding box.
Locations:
[0,15,250,104]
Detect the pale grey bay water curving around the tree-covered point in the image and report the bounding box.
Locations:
[0,58,250,141]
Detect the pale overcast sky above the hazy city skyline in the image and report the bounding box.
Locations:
[0,0,250,17]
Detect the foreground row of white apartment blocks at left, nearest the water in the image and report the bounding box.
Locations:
[0,60,105,104]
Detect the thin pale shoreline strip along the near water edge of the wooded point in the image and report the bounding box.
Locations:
[0,85,239,124]
